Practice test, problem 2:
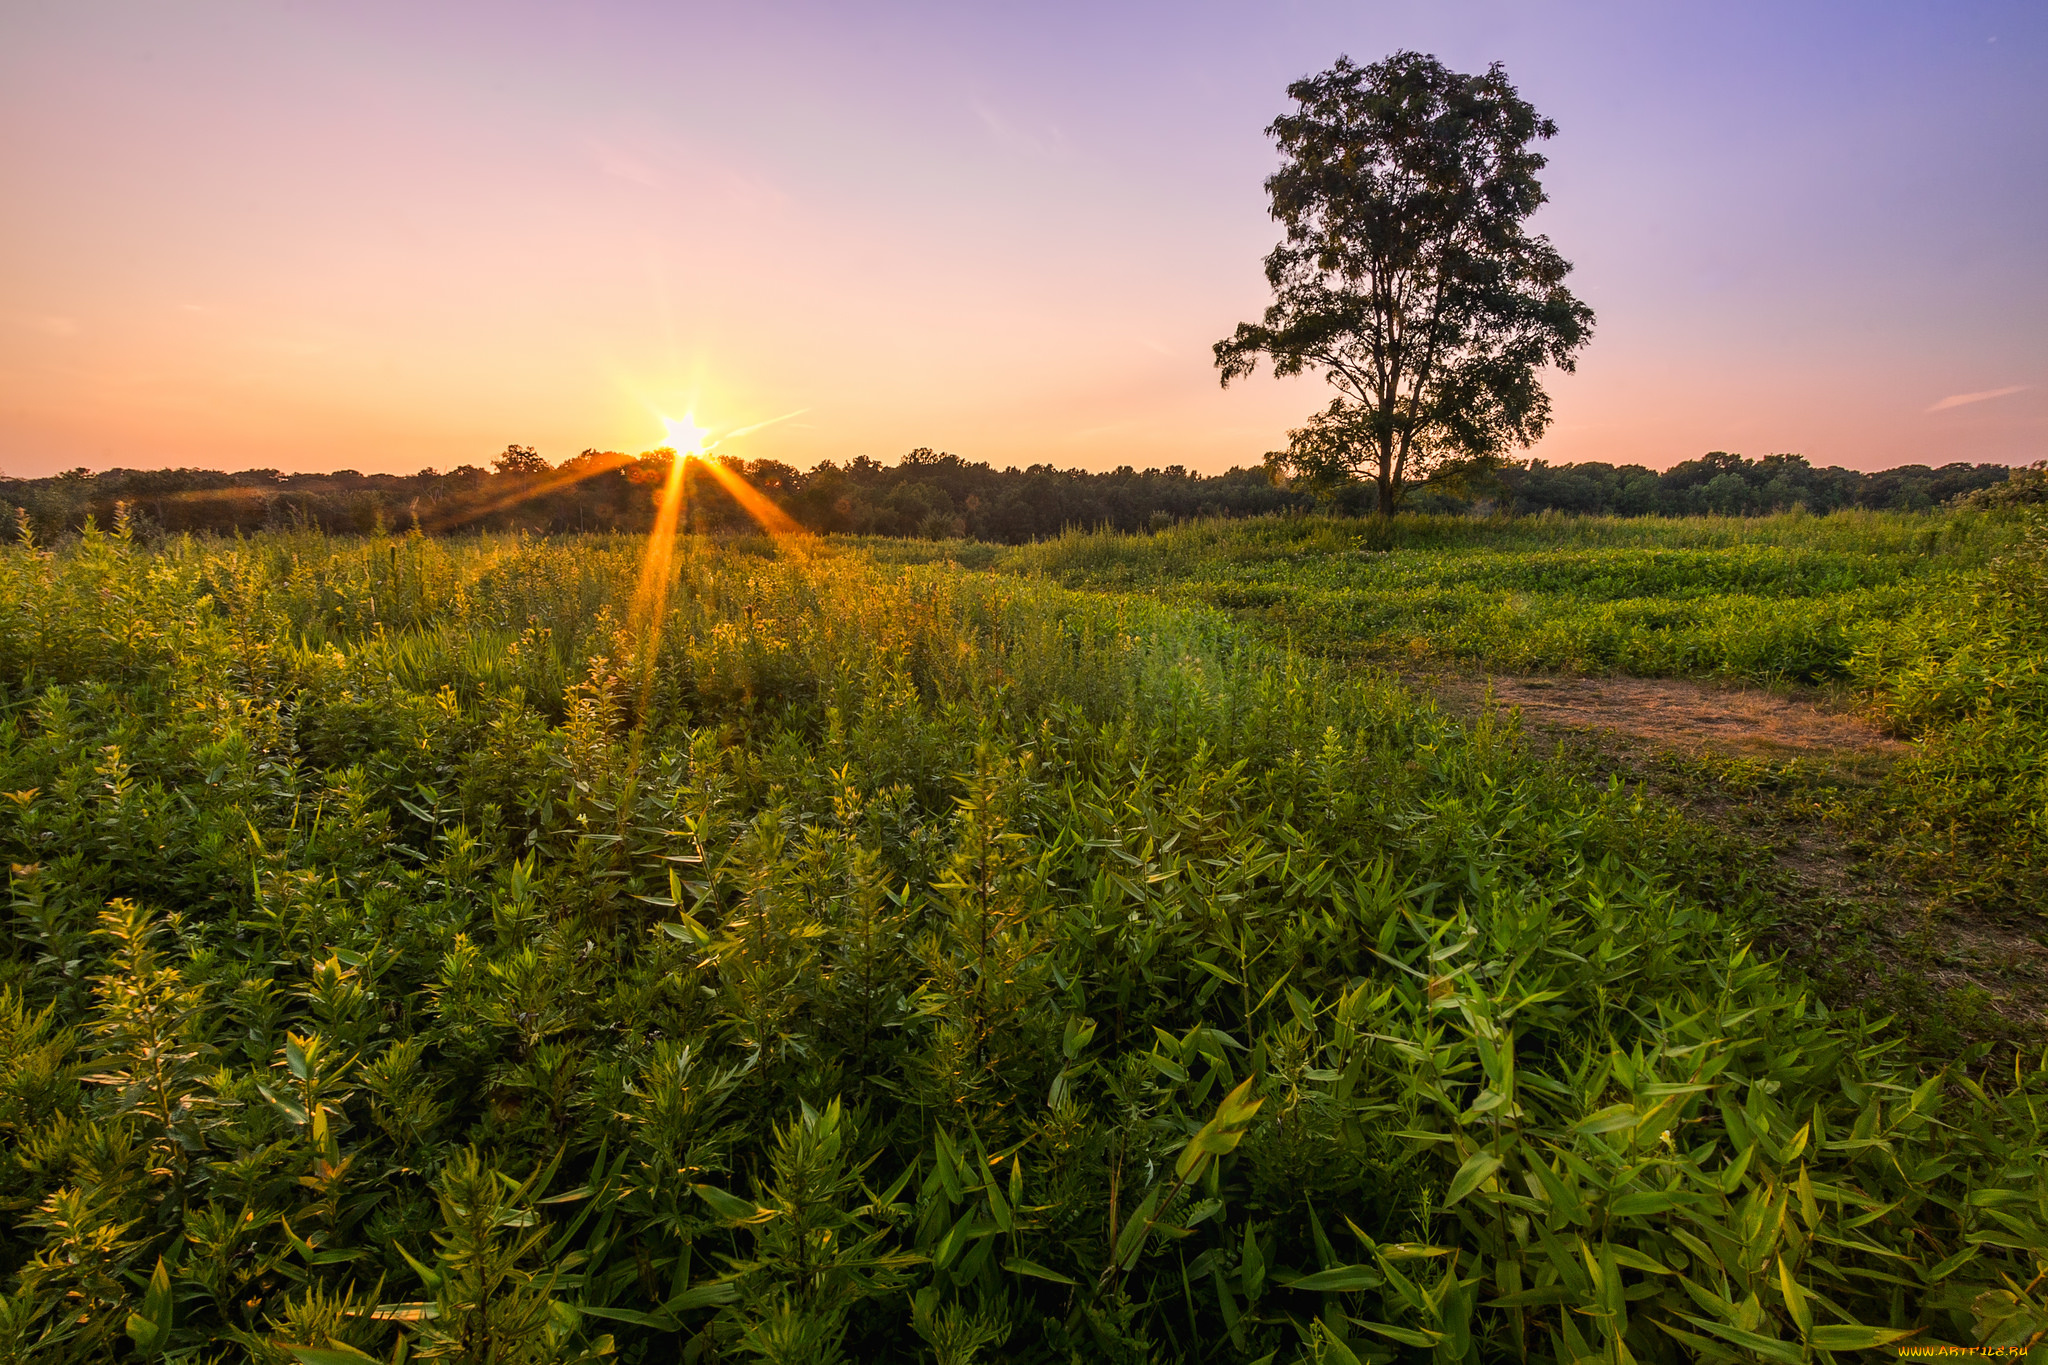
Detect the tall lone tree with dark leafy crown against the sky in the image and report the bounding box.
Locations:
[1217,51,1593,516]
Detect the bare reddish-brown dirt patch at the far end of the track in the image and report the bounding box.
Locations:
[1436,677,1907,763]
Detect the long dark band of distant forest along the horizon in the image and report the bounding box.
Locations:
[0,446,2011,544]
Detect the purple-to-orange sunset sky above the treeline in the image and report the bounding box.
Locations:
[0,0,2048,477]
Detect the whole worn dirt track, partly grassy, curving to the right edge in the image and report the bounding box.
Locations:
[1409,673,2048,1046]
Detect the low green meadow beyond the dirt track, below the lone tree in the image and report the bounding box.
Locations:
[991,510,2048,919]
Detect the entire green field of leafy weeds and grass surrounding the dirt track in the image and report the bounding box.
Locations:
[0,514,2048,1365]
